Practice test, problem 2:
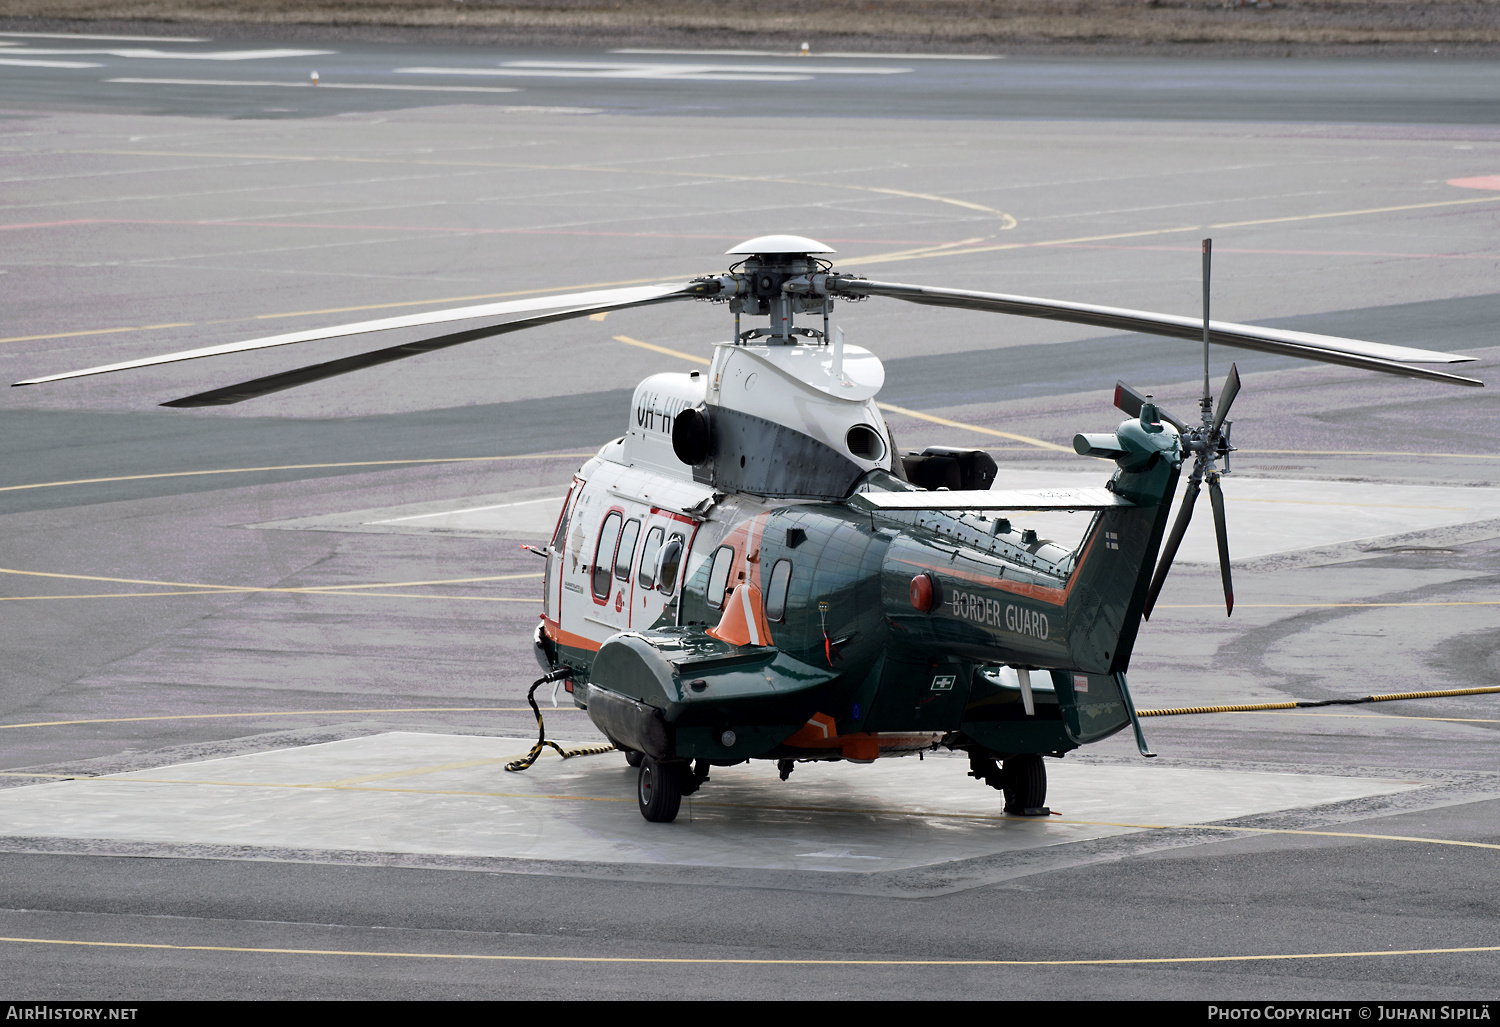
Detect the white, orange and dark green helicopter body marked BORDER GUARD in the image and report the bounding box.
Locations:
[542,345,1176,762]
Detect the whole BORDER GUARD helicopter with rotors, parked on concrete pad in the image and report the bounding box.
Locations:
[15,235,1484,822]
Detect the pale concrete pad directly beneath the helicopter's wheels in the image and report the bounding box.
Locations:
[0,732,1419,871]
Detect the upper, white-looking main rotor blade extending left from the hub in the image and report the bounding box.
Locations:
[15,283,695,385]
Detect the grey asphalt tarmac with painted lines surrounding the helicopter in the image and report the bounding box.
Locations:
[0,36,1500,1002]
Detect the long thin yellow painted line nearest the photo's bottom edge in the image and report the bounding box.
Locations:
[0,937,1500,967]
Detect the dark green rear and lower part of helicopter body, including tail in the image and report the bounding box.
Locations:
[569,421,1181,762]
